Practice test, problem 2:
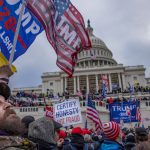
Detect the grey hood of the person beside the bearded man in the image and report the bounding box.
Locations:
[28,117,60,144]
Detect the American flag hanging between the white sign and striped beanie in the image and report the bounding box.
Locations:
[86,96,103,131]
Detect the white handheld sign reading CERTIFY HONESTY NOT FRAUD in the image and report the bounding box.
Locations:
[54,99,82,126]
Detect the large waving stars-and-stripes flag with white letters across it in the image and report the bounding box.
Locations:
[27,0,91,76]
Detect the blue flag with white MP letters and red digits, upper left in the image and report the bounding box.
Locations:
[0,0,43,61]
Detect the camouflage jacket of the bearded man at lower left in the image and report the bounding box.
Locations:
[0,136,37,150]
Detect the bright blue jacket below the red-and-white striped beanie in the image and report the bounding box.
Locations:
[98,140,125,150]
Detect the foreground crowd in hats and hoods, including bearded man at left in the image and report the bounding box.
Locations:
[0,66,150,150]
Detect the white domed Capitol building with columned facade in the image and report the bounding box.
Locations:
[13,21,146,95]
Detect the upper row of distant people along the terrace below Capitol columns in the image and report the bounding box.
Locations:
[14,86,150,100]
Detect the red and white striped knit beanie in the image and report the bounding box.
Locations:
[103,121,120,140]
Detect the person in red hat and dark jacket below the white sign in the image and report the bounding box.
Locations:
[63,127,84,150]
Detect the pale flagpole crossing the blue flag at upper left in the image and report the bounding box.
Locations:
[9,0,26,66]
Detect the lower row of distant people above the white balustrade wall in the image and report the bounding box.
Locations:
[9,91,150,108]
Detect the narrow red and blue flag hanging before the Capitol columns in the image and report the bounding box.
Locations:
[102,75,108,98]
